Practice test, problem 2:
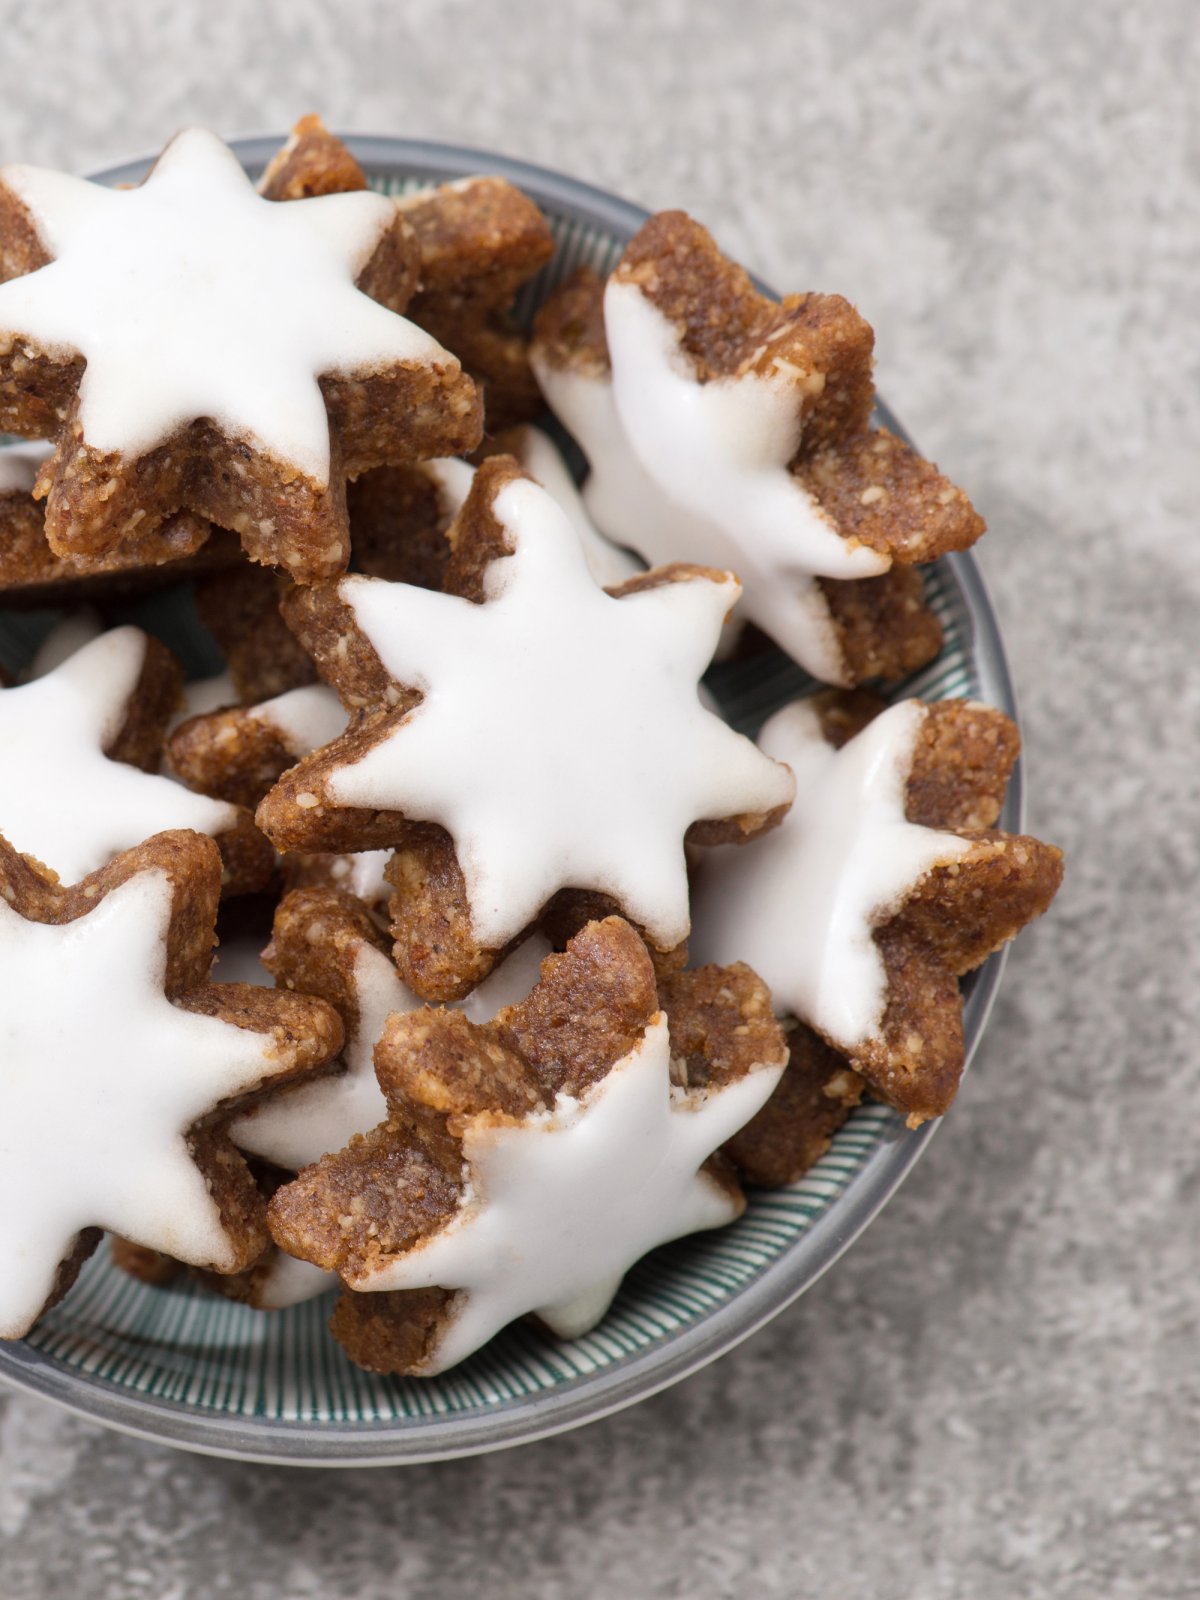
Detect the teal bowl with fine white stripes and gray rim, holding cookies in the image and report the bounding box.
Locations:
[0,138,1021,1466]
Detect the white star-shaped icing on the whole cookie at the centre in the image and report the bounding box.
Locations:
[328,480,794,949]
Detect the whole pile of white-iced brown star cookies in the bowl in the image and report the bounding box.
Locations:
[0,118,1061,1374]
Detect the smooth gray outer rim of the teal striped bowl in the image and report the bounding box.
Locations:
[0,134,1024,1467]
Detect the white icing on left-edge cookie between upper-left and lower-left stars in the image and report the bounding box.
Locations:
[0,627,237,883]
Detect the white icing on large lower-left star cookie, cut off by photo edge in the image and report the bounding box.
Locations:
[0,869,294,1338]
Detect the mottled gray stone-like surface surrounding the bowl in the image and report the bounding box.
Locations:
[0,0,1200,1600]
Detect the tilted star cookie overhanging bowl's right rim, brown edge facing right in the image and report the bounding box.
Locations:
[693,696,1062,1126]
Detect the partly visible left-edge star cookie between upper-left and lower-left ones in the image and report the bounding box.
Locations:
[0,627,274,893]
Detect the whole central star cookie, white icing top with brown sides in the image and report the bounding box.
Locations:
[258,456,792,1000]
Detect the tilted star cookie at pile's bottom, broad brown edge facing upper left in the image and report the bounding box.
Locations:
[269,918,786,1374]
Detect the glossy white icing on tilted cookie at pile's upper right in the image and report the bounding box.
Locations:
[531,280,891,683]
